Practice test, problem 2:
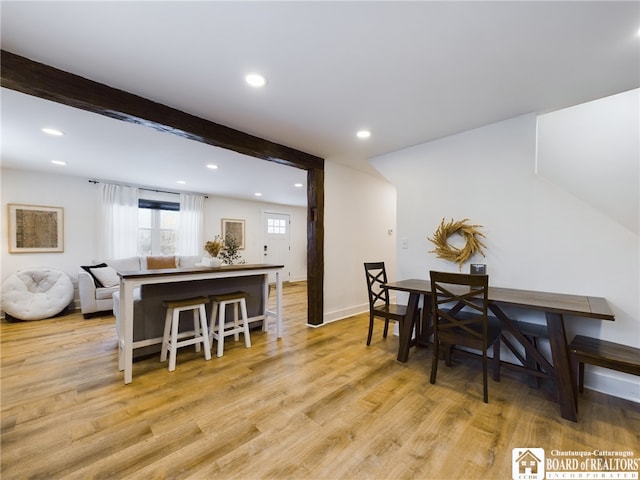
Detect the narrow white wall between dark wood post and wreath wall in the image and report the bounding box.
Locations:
[323,161,397,322]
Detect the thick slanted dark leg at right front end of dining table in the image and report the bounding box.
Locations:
[546,312,578,422]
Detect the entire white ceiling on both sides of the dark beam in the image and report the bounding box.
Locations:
[0,1,640,205]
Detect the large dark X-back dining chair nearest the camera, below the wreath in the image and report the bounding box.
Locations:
[430,271,501,403]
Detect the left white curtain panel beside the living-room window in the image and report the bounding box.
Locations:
[99,183,138,258]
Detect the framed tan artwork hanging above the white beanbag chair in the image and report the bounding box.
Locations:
[8,203,64,253]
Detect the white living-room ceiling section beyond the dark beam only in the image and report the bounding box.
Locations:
[1,88,307,206]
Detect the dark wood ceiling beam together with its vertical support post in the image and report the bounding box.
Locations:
[0,50,324,325]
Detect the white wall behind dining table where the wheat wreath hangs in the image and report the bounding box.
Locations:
[371,115,640,401]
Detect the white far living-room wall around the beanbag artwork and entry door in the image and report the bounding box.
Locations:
[0,168,307,308]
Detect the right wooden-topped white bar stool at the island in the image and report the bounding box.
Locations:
[209,292,251,357]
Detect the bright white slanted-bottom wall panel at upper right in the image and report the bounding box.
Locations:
[537,89,640,234]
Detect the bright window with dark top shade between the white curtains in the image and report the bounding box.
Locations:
[138,199,180,255]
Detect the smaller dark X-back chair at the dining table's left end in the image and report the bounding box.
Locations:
[364,262,407,345]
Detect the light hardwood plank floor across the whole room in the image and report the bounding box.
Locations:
[0,283,640,480]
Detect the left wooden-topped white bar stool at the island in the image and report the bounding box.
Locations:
[160,297,211,372]
